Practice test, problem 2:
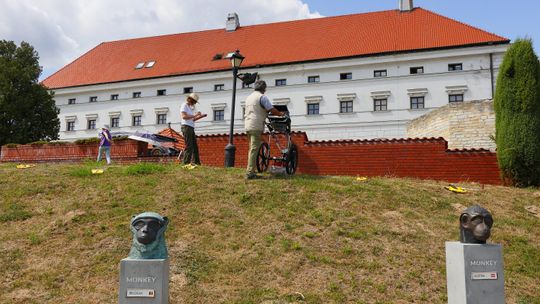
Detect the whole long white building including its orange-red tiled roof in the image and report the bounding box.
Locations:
[44,0,509,140]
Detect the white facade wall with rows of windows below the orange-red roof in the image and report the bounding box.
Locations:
[55,45,508,140]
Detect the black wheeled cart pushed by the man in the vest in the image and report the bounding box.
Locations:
[257,105,298,175]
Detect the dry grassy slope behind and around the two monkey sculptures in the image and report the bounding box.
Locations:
[0,164,540,303]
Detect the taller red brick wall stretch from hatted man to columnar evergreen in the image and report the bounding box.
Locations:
[197,132,501,184]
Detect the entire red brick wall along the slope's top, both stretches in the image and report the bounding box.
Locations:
[0,132,502,184]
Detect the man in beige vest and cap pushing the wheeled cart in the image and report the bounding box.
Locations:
[244,80,283,179]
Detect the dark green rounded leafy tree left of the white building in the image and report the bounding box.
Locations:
[0,40,60,145]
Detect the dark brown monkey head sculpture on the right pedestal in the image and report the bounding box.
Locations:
[459,205,493,244]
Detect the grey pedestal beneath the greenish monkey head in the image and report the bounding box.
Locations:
[118,259,169,304]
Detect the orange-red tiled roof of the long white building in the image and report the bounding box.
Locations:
[43,8,509,89]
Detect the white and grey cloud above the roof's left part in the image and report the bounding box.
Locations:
[0,0,321,78]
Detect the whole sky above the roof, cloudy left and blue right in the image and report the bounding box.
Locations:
[0,0,540,80]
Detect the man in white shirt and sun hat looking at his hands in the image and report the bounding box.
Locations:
[180,93,206,165]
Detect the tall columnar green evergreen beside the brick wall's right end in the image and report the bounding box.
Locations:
[494,39,540,187]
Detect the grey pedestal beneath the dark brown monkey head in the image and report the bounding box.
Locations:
[446,242,505,304]
